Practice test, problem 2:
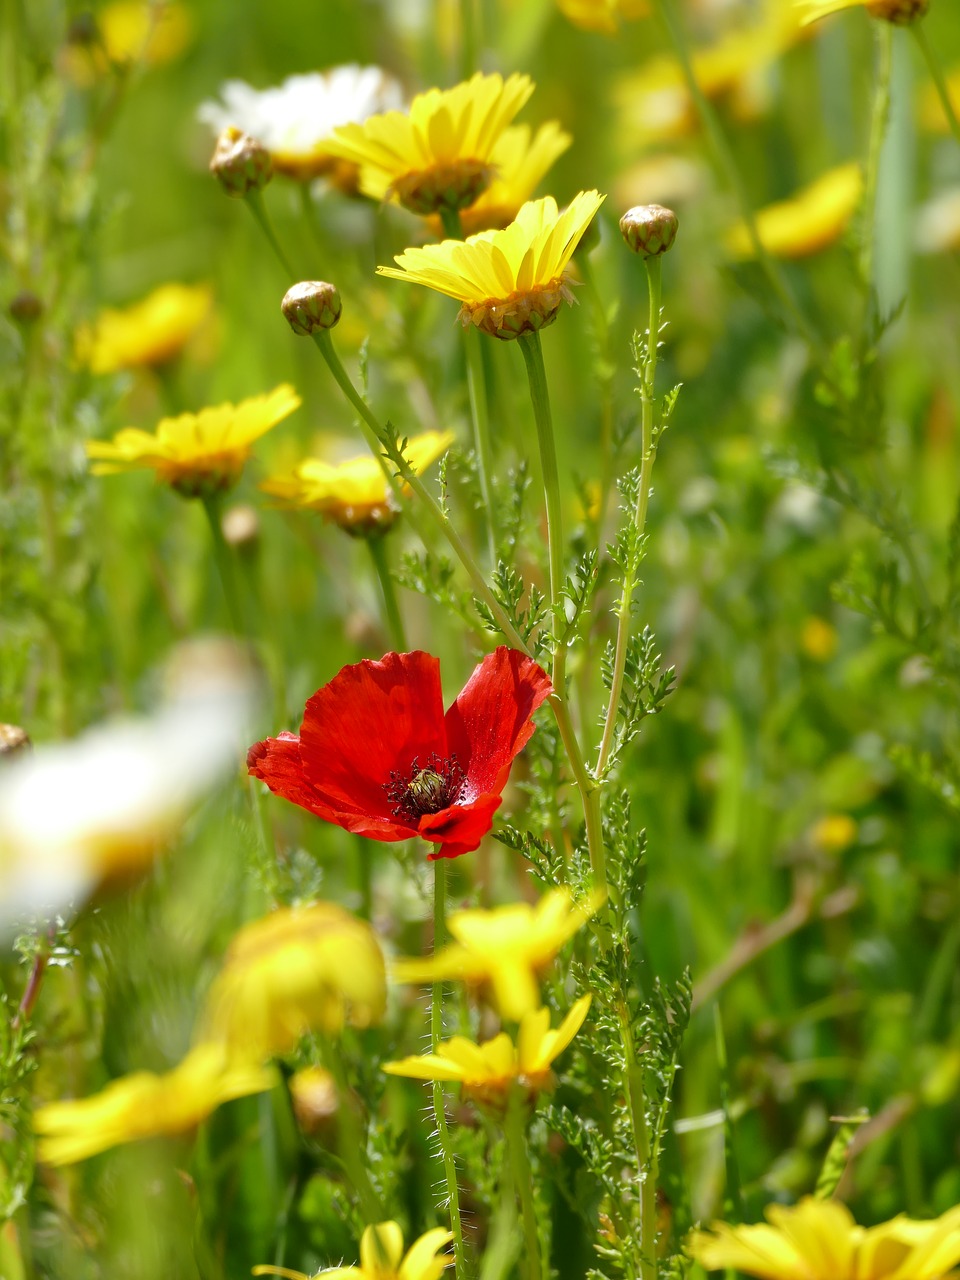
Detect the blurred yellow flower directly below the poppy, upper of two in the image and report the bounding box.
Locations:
[393,888,603,1021]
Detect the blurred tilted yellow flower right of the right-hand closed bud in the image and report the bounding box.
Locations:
[726,161,863,259]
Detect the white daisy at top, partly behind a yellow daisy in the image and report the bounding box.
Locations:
[197,64,403,189]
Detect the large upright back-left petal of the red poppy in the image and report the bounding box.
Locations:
[300,650,447,819]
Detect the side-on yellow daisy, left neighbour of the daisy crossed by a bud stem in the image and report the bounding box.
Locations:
[87,383,301,498]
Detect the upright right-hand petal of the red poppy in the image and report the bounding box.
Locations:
[445,645,553,800]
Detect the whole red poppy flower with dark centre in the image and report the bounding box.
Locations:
[247,645,553,858]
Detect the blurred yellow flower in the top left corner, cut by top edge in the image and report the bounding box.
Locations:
[64,0,193,88]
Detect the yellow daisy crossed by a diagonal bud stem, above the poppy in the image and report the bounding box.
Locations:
[260,431,454,536]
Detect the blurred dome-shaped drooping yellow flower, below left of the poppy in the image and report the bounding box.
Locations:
[202,902,387,1060]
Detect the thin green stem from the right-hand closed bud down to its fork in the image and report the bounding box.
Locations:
[595,257,662,783]
